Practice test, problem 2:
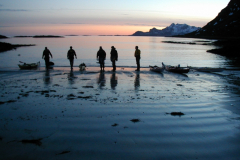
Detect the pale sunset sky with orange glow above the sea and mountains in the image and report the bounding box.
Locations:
[0,0,230,36]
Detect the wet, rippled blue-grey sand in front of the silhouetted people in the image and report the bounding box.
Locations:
[0,68,240,160]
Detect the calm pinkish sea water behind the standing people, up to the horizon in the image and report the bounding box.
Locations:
[0,36,229,69]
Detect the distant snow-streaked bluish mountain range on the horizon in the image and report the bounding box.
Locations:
[132,23,200,36]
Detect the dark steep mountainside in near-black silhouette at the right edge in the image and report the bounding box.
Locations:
[186,0,240,38]
